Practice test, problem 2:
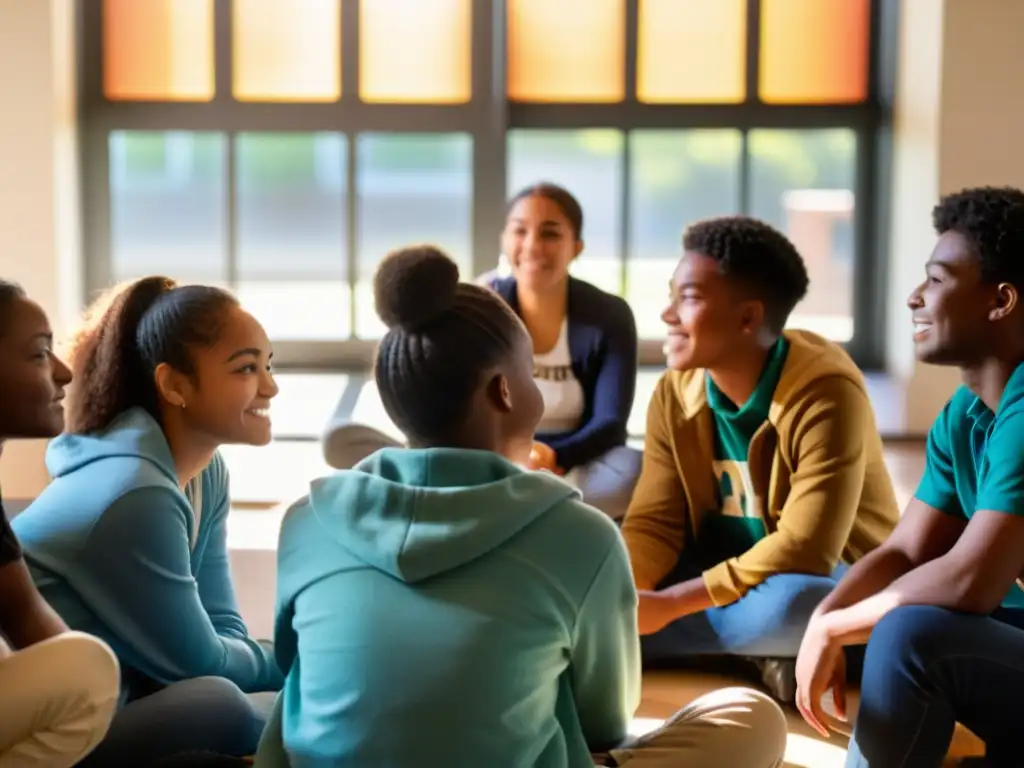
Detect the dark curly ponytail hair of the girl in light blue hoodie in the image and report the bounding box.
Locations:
[67,276,238,433]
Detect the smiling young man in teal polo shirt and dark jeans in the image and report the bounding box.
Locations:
[797,187,1024,768]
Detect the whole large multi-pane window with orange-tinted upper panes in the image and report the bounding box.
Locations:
[79,0,895,369]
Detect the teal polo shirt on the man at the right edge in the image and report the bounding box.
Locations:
[914,364,1024,608]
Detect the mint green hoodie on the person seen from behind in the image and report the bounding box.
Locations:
[257,449,640,768]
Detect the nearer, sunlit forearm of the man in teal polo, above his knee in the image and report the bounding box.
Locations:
[821,557,976,645]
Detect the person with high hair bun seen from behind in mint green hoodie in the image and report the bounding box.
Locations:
[256,247,785,768]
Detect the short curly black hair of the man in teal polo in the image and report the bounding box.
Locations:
[932,186,1024,290]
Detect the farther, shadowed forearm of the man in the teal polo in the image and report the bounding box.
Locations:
[815,499,967,615]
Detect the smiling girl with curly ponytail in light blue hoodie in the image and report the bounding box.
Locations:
[13,278,283,767]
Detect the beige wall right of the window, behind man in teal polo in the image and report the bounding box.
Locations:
[887,0,1024,434]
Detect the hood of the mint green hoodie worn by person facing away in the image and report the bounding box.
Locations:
[309,449,580,584]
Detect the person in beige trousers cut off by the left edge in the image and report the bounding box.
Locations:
[0,280,121,768]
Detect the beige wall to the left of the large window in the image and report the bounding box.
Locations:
[0,0,82,498]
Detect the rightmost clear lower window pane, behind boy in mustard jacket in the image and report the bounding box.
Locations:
[750,128,857,341]
